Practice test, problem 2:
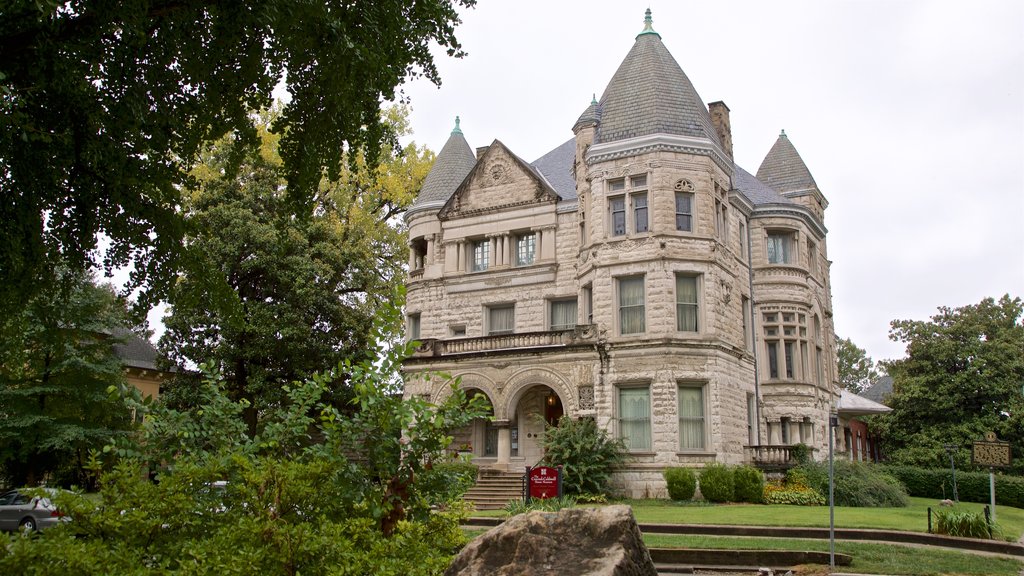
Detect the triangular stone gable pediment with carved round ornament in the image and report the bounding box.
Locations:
[438,140,558,219]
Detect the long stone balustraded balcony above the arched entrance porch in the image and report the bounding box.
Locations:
[413,324,597,358]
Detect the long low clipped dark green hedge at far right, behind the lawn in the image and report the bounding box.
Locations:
[884,464,1024,508]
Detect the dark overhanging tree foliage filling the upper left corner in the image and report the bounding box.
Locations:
[0,0,475,313]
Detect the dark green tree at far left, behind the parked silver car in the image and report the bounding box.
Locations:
[0,271,131,485]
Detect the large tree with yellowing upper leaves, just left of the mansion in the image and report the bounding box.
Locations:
[160,108,433,436]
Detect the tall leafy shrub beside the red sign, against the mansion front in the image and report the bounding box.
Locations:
[544,417,626,494]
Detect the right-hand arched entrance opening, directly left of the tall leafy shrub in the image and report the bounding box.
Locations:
[509,384,565,466]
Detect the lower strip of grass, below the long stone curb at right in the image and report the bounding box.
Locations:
[643,534,1024,576]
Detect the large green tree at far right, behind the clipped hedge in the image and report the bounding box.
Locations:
[871,295,1024,467]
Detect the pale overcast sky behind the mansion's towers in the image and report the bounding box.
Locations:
[395,0,1024,360]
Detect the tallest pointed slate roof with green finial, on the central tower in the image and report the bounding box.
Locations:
[584,14,721,146]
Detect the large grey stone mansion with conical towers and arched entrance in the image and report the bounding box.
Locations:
[403,10,840,496]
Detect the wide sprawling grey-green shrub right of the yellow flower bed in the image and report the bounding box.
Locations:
[787,460,908,508]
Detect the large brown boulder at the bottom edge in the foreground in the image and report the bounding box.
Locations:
[444,505,657,576]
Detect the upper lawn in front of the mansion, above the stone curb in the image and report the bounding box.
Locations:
[474,498,1024,541]
